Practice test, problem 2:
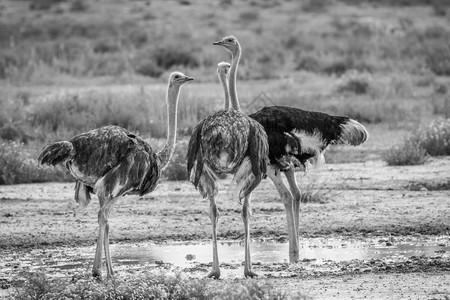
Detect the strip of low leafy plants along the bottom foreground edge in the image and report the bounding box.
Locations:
[13,271,308,300]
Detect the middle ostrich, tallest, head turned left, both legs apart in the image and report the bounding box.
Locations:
[187,37,269,278]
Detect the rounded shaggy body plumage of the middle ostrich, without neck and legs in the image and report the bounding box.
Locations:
[187,109,269,198]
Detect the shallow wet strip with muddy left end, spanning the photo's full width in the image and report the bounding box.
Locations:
[0,236,450,277]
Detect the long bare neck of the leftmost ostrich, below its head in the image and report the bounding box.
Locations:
[156,86,180,169]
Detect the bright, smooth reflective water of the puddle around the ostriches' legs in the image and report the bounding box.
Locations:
[112,239,450,267]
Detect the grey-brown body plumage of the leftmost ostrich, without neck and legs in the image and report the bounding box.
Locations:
[38,126,160,205]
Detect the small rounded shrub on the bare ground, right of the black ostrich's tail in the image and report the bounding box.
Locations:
[383,139,428,166]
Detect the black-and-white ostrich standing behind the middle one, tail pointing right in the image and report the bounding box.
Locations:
[215,52,369,262]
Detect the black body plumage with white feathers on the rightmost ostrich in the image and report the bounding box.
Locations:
[249,106,368,171]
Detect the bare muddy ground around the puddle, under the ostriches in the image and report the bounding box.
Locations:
[0,157,450,299]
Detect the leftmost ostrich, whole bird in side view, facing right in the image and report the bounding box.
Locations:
[38,72,193,279]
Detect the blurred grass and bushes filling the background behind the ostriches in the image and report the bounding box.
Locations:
[0,0,450,184]
